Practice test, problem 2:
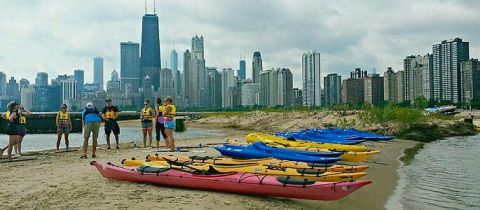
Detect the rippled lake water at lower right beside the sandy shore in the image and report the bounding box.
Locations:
[386,136,480,209]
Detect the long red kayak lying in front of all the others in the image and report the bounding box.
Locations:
[90,161,372,200]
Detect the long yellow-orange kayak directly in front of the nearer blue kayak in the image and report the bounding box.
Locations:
[147,155,368,172]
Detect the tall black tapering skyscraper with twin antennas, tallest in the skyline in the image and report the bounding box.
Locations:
[140,14,161,90]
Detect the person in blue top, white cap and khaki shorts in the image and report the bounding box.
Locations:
[80,102,102,159]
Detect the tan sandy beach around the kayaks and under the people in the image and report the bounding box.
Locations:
[0,120,416,209]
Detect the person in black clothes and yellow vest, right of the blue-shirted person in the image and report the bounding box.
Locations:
[102,98,120,149]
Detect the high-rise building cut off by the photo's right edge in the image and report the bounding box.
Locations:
[460,59,480,103]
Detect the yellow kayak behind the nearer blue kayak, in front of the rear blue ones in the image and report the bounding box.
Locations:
[246,132,369,152]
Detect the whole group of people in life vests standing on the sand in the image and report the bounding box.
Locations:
[0,97,176,160]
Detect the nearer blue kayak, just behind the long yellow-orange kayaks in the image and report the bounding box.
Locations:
[215,145,340,164]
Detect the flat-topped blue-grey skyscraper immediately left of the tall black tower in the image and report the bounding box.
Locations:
[120,42,140,92]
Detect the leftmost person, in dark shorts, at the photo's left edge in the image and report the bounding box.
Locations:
[0,101,20,161]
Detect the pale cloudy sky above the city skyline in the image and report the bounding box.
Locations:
[0,0,480,87]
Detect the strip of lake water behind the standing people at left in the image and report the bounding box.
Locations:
[0,127,224,154]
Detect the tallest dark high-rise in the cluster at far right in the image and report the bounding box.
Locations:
[432,38,469,103]
